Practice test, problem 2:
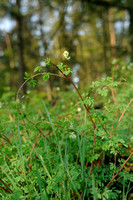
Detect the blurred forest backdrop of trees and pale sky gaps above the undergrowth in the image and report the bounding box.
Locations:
[0,0,133,97]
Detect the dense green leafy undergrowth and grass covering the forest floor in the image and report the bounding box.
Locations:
[0,59,133,200]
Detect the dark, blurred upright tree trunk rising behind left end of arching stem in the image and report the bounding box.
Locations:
[16,0,26,94]
